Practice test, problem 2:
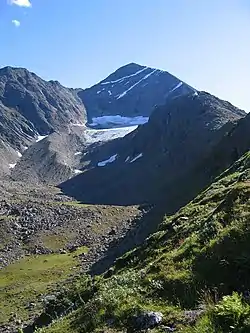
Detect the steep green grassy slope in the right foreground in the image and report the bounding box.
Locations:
[42,153,250,333]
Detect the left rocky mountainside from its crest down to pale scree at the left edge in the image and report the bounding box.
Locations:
[0,67,86,175]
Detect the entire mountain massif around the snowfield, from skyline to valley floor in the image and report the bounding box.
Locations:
[0,64,244,192]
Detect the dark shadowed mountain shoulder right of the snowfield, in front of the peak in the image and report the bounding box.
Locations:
[61,92,245,210]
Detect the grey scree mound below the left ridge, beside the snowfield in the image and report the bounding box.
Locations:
[11,130,88,184]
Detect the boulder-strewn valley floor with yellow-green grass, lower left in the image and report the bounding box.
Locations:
[0,181,142,332]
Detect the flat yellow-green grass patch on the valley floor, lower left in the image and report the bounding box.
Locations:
[0,247,87,323]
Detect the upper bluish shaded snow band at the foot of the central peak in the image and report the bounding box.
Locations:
[90,115,149,126]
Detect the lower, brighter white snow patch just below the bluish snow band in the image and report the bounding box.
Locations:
[84,126,137,144]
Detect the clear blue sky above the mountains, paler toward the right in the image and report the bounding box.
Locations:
[0,0,250,111]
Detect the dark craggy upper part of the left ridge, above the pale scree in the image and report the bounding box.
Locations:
[0,67,86,135]
